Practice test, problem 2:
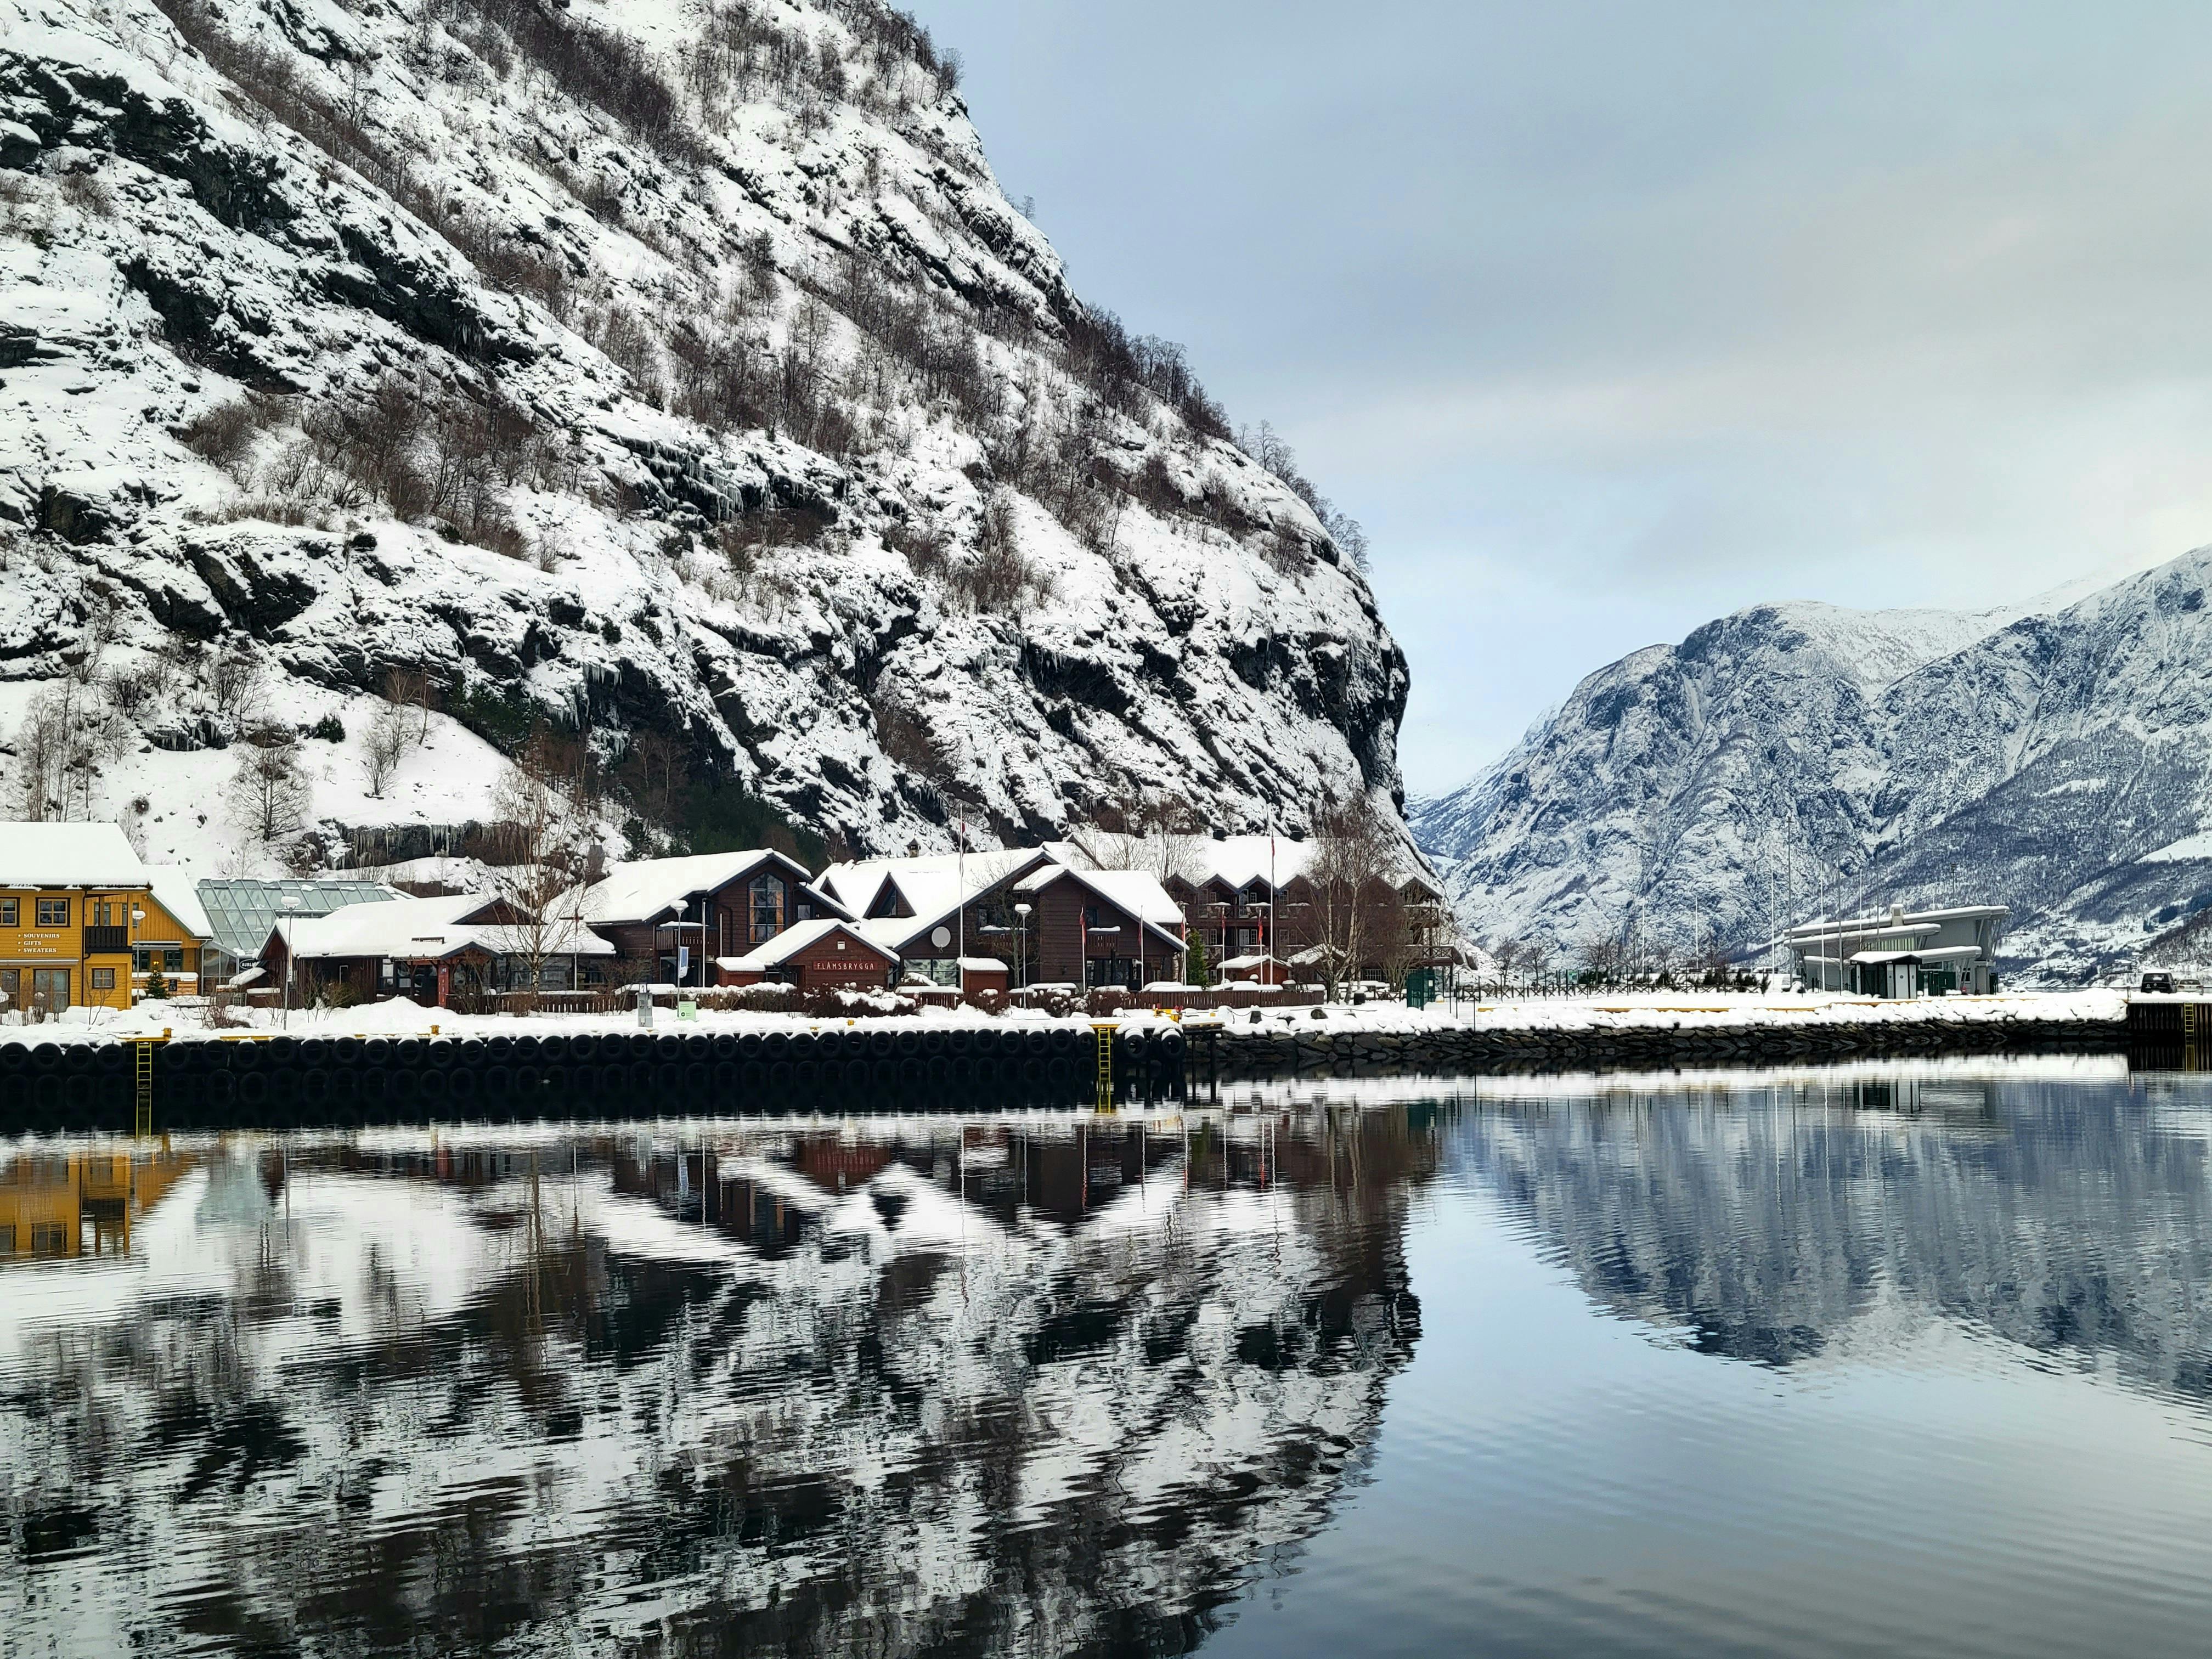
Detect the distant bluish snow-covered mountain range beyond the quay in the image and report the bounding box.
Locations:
[1411,551,2212,980]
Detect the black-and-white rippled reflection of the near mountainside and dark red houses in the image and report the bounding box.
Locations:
[0,1110,1438,1655]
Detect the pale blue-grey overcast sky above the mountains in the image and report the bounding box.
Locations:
[918,0,2212,794]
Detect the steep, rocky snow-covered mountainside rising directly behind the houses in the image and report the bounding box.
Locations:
[0,0,1407,862]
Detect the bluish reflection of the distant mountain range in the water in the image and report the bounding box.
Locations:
[1460,1062,2212,1400]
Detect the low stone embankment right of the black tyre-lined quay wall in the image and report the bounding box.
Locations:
[1190,1015,2128,1084]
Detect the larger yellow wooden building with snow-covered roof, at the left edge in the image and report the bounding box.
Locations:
[0,823,156,1015]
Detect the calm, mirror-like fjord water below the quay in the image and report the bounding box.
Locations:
[0,1062,2212,1659]
